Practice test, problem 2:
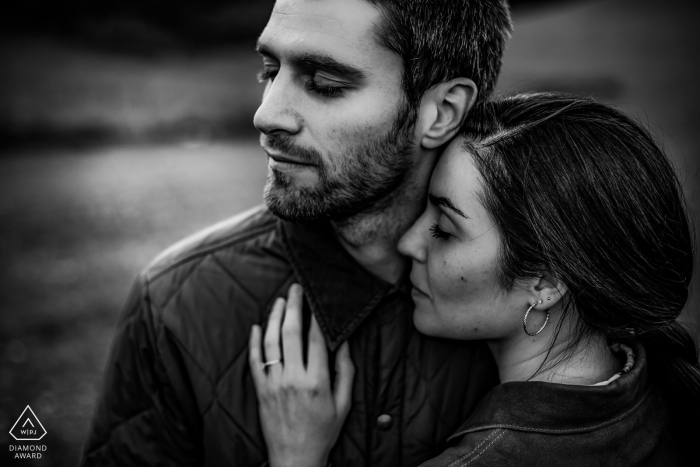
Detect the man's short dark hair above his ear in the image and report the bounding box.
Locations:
[367,0,512,109]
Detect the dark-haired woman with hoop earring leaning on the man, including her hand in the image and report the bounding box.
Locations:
[250,94,700,467]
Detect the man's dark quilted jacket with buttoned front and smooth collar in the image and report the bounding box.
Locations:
[82,208,498,467]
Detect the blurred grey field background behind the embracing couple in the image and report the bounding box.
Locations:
[0,0,700,466]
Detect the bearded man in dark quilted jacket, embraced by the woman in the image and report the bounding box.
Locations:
[83,0,510,466]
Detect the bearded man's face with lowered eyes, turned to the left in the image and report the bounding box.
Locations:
[254,0,414,220]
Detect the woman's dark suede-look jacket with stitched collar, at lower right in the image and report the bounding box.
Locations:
[421,344,686,467]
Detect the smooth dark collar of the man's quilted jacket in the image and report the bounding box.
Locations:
[280,221,394,351]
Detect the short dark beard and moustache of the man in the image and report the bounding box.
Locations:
[261,104,415,222]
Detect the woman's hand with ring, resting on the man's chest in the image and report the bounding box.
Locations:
[249,284,355,467]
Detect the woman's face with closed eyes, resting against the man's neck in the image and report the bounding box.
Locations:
[399,138,531,339]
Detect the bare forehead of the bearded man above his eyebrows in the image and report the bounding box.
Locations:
[260,0,380,55]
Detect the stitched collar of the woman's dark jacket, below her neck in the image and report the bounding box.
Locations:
[449,343,651,439]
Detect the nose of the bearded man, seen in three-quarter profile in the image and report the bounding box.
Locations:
[253,73,302,135]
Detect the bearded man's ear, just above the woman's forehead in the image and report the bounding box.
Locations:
[418,78,477,149]
